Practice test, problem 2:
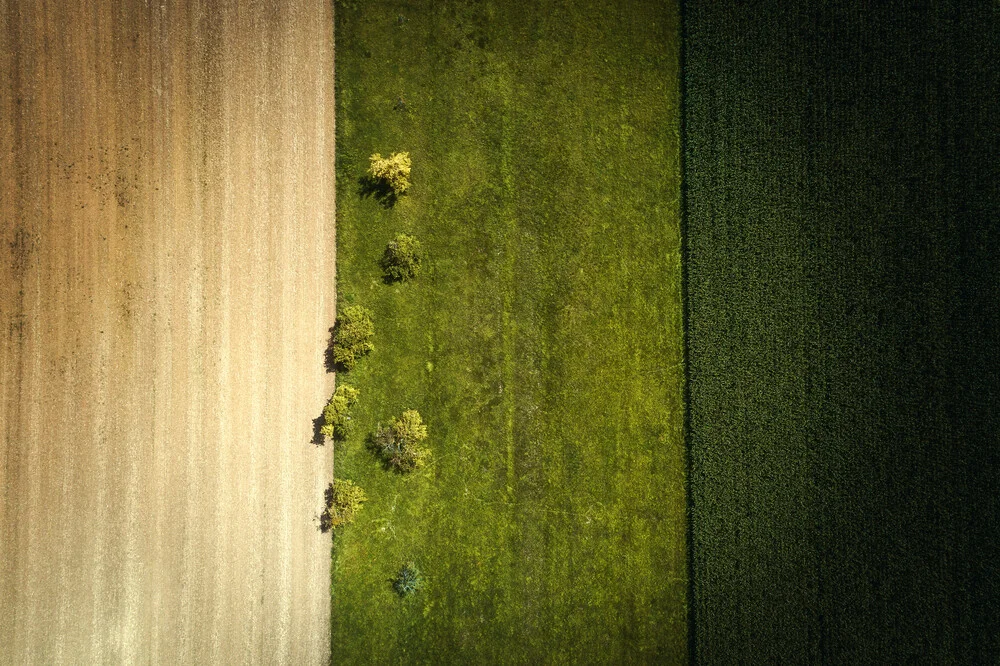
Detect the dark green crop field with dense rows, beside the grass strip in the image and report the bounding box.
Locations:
[684,2,1000,664]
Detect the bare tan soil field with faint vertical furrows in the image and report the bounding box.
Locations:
[0,0,335,664]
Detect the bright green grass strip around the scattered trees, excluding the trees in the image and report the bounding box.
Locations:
[328,0,688,663]
